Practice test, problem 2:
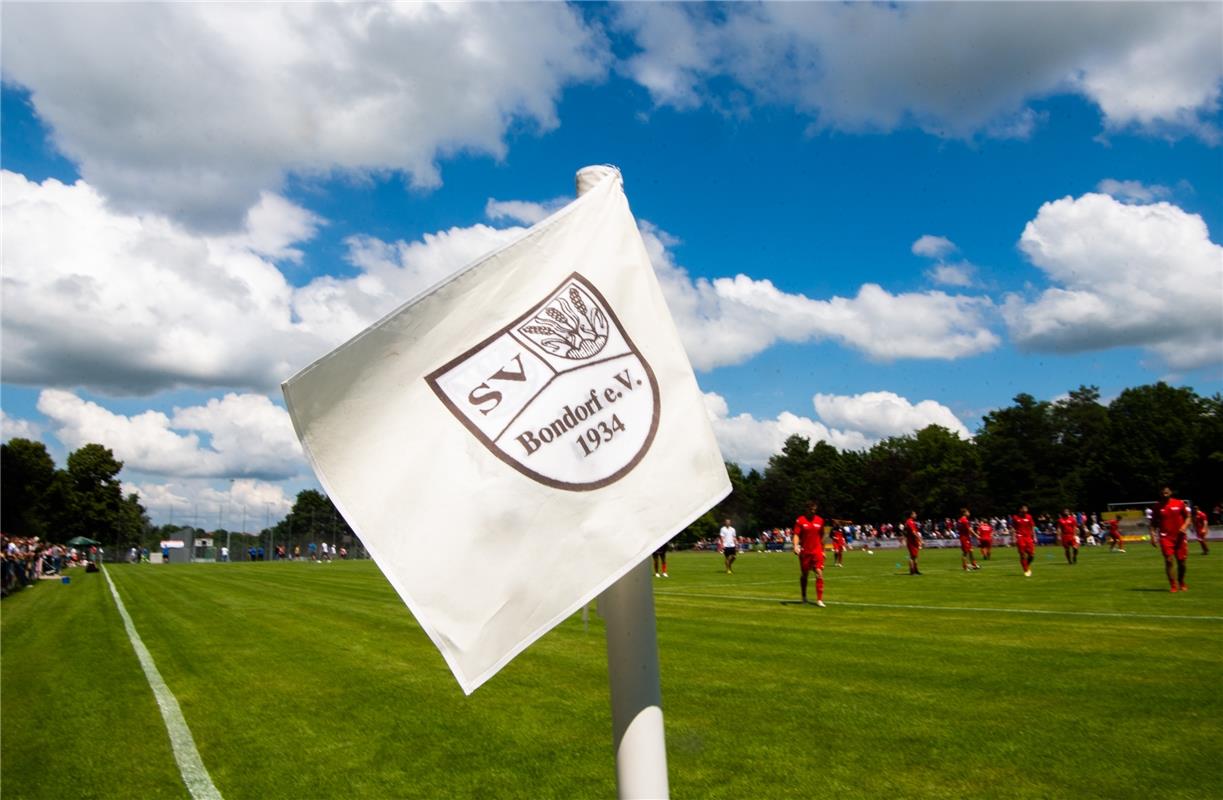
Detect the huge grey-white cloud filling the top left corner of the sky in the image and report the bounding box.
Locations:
[2,2,608,230]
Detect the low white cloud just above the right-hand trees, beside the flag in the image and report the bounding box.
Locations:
[704,391,969,469]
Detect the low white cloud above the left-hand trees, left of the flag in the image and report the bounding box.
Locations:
[38,389,306,480]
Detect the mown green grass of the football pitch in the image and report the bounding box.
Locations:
[0,544,1223,800]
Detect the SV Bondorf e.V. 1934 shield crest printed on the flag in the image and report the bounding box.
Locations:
[426,273,659,491]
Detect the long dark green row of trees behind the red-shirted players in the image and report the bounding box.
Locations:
[699,382,1223,539]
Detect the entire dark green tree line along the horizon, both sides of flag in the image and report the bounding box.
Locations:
[0,382,1223,549]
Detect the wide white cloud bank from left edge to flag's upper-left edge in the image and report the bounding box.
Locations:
[0,171,521,394]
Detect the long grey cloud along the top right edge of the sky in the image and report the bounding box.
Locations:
[615,2,1223,139]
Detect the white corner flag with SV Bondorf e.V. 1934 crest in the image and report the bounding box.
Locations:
[283,168,730,694]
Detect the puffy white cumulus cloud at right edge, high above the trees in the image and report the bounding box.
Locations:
[1003,193,1223,369]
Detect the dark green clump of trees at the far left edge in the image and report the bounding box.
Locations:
[0,439,149,547]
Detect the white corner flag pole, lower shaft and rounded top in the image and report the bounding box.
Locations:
[577,166,670,800]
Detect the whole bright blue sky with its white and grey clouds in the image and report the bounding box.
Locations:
[0,4,1223,527]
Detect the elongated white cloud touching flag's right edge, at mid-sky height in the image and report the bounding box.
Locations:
[643,226,999,369]
